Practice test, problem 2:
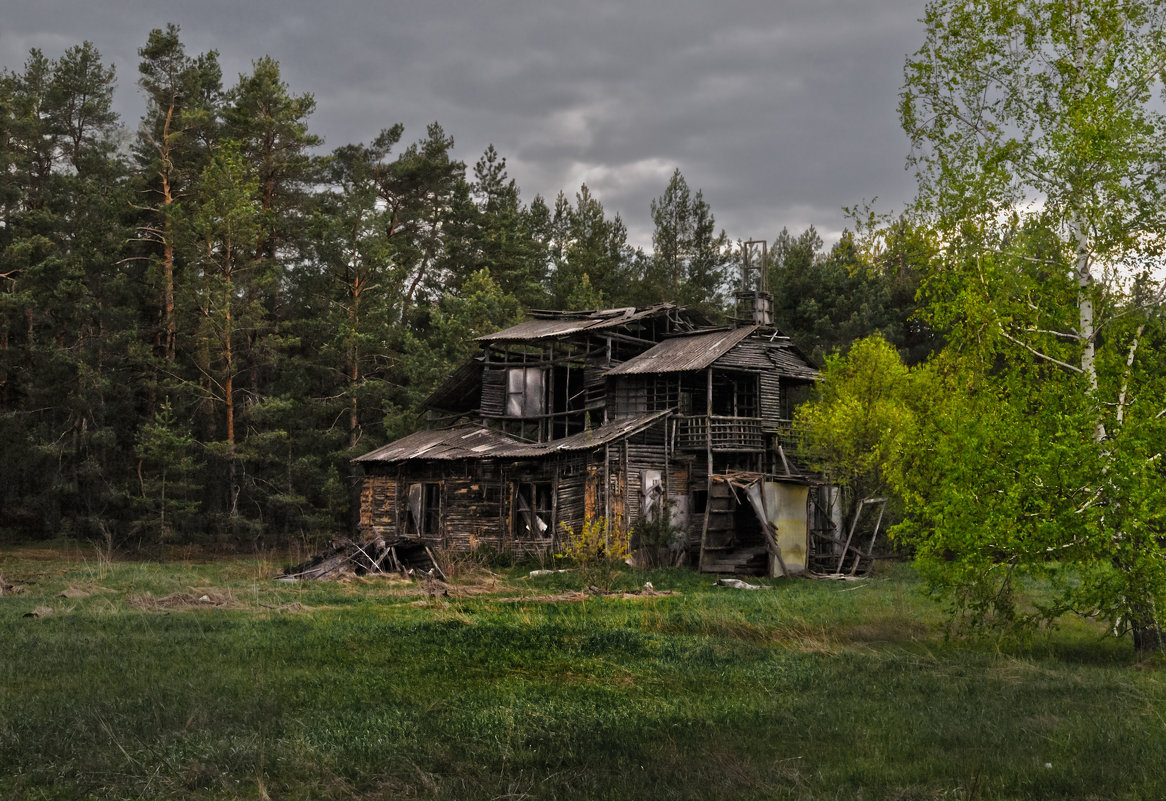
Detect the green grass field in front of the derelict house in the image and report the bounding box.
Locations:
[0,546,1166,801]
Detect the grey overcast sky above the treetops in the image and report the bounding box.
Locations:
[0,0,923,246]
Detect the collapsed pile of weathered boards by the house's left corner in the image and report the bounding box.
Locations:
[279,537,445,582]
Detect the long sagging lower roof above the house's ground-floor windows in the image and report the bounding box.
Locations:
[352,412,669,463]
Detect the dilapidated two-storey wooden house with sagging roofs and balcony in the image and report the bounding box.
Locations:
[356,244,837,575]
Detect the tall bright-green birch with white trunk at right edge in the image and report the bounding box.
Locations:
[901,0,1166,648]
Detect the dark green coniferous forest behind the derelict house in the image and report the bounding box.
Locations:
[0,26,932,548]
